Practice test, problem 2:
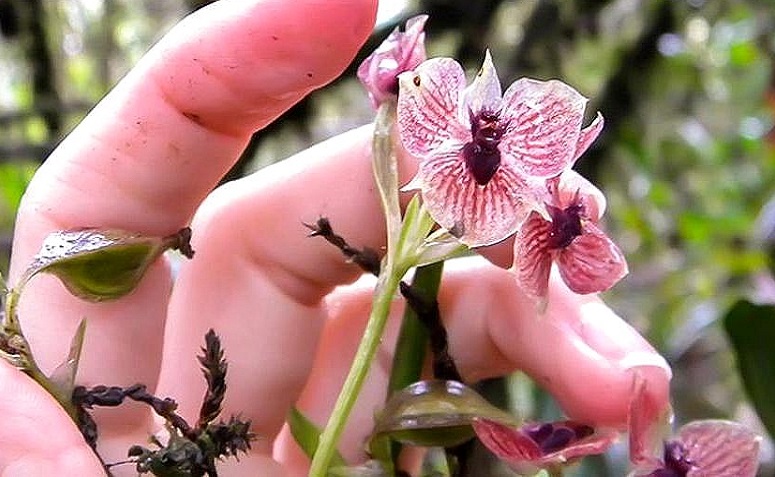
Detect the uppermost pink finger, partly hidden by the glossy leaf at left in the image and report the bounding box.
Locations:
[12,0,375,420]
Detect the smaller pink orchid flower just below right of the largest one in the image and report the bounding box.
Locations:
[514,170,627,298]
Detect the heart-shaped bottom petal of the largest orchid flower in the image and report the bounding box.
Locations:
[410,151,532,247]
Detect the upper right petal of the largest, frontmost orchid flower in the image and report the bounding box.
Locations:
[500,78,587,177]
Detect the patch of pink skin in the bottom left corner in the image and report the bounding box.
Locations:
[0,359,102,477]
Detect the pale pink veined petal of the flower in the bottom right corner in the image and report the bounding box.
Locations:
[677,420,761,477]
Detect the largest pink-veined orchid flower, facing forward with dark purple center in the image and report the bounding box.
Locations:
[398,52,603,247]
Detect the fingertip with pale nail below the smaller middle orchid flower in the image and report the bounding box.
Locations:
[546,276,672,429]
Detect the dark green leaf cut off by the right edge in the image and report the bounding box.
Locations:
[724,300,775,436]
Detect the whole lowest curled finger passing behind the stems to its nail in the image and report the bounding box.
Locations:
[275,259,670,468]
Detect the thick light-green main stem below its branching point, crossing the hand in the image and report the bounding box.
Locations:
[309,267,406,477]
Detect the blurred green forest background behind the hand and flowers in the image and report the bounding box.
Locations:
[0,0,775,475]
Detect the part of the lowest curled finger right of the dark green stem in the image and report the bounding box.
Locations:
[440,256,671,429]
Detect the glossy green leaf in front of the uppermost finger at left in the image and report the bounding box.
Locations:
[15,228,193,301]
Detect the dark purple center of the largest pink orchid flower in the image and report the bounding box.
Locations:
[463,111,504,185]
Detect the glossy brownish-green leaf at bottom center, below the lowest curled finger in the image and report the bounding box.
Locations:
[372,380,518,447]
